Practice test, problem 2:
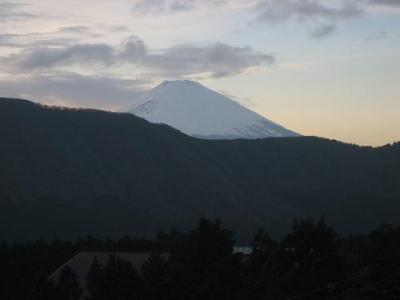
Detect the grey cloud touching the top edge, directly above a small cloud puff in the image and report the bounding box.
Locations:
[256,0,363,23]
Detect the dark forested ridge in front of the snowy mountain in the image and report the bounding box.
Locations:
[0,99,400,240]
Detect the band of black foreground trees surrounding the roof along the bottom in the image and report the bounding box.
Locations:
[0,219,400,300]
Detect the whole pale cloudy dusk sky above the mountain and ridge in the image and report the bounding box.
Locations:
[0,0,400,146]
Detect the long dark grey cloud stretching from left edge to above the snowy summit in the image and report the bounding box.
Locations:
[2,36,275,77]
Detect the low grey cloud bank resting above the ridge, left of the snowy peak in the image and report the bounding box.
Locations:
[0,73,146,110]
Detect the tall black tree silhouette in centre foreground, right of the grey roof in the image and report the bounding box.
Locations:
[171,218,240,299]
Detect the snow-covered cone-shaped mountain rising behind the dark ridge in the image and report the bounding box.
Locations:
[122,80,298,139]
